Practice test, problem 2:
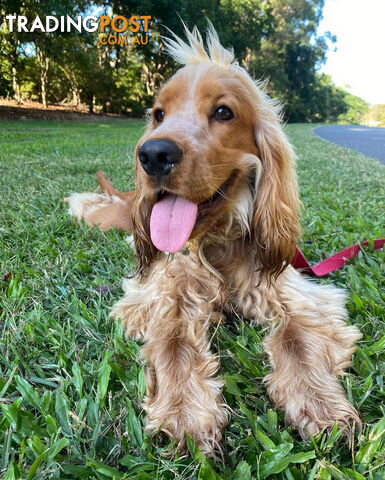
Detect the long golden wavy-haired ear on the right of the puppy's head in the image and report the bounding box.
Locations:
[253,122,301,278]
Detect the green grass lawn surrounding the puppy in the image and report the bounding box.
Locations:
[0,120,385,480]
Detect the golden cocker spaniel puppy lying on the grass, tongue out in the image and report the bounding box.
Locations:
[68,25,360,453]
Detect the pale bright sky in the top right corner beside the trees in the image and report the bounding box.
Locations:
[318,0,385,105]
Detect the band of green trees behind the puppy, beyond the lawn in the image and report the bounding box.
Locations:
[0,0,364,122]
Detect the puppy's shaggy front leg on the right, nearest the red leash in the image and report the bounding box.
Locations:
[232,267,361,438]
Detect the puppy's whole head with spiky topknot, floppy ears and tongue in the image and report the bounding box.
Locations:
[133,26,299,274]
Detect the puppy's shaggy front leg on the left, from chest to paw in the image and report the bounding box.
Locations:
[113,253,228,454]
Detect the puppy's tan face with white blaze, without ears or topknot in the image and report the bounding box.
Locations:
[136,63,257,251]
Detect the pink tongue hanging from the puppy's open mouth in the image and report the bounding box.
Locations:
[150,194,198,253]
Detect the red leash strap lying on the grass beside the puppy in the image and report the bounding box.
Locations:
[291,238,385,277]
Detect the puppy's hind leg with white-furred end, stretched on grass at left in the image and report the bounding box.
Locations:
[65,171,135,232]
